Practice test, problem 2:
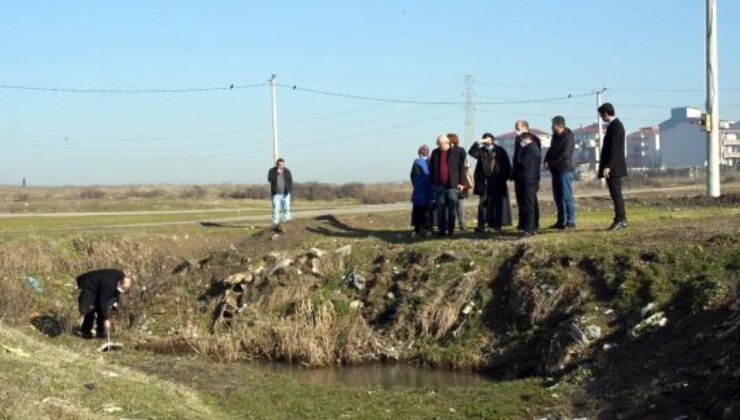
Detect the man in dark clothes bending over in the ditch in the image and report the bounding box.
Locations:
[77,268,132,338]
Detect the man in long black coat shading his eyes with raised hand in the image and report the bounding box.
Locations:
[468,133,511,232]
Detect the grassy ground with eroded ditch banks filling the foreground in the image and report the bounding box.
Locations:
[0,188,740,418]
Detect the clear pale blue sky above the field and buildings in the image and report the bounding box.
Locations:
[0,0,740,185]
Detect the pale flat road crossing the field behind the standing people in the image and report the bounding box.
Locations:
[0,185,720,233]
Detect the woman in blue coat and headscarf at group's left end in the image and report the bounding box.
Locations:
[411,144,434,236]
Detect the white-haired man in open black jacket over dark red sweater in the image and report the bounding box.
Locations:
[429,135,465,237]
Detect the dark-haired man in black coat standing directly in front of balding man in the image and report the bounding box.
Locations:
[513,133,542,237]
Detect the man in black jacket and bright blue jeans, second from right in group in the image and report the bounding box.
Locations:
[545,115,576,230]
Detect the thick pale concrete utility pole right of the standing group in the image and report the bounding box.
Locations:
[706,0,720,197]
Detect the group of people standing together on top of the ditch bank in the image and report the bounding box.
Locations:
[411,103,627,237]
